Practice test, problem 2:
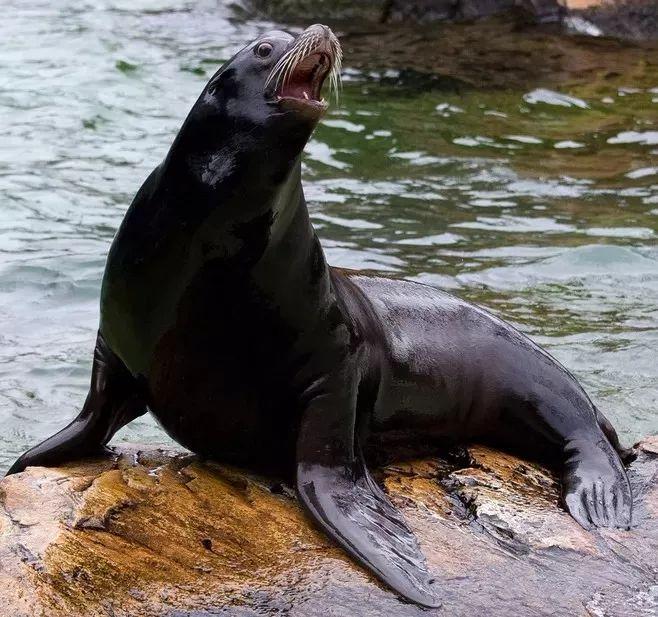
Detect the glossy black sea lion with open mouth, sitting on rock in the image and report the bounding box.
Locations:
[9,25,632,606]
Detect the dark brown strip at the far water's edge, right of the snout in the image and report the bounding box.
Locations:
[337,18,658,90]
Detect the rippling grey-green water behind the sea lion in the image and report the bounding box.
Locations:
[0,0,658,471]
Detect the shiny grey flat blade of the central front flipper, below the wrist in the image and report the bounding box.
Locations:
[297,442,441,608]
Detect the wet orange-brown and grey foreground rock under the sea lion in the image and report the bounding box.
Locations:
[0,437,658,617]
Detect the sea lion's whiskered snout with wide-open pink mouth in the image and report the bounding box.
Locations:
[266,24,343,115]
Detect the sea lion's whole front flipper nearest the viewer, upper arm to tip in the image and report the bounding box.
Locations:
[297,366,440,607]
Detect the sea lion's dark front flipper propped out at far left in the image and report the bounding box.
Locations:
[7,333,146,475]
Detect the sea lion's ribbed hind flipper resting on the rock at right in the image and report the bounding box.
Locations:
[562,434,633,529]
